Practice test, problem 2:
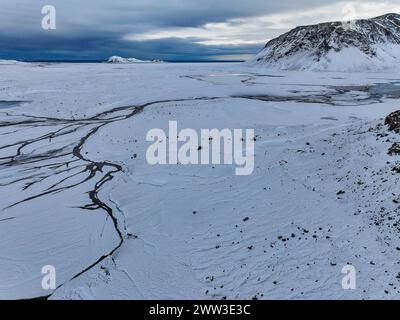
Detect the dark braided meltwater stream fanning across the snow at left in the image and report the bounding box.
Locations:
[0,97,220,298]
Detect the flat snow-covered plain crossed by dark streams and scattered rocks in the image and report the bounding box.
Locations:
[0,64,400,299]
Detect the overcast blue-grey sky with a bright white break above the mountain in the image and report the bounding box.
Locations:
[0,0,400,61]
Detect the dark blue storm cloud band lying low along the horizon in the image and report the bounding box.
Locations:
[0,34,260,61]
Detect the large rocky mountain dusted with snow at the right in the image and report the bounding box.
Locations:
[249,13,400,71]
